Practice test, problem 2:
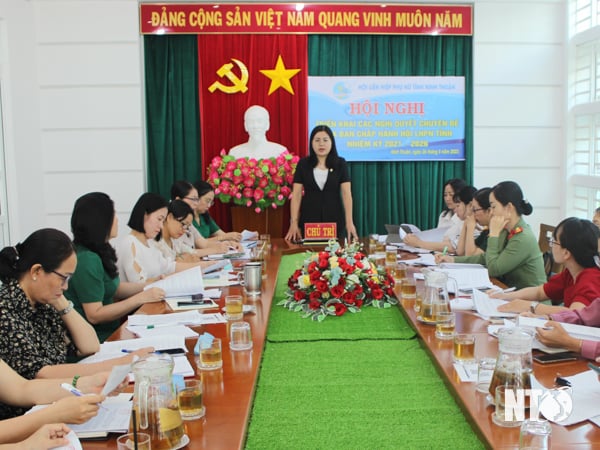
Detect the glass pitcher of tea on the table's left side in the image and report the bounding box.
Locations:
[133,353,184,450]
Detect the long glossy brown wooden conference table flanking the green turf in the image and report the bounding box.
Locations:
[82,239,600,450]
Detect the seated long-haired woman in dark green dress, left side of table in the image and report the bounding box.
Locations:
[65,192,165,342]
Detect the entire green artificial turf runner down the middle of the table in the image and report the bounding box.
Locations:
[246,255,483,450]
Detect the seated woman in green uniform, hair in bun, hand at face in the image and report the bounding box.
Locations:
[436,181,546,289]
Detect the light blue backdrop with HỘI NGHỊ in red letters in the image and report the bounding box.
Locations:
[308,77,465,161]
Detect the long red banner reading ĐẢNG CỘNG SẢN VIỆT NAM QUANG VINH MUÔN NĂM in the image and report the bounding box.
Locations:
[140,3,473,36]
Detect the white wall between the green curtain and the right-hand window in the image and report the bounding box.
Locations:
[473,0,567,232]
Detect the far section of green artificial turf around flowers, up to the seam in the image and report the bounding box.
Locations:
[267,253,415,342]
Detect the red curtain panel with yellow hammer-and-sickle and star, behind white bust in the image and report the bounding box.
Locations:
[198,34,308,231]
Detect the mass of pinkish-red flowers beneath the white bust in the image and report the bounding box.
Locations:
[207,149,300,213]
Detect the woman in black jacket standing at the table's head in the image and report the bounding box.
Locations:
[285,125,358,240]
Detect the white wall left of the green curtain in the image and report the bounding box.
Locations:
[0,0,145,242]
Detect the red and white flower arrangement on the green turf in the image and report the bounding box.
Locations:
[278,240,398,322]
